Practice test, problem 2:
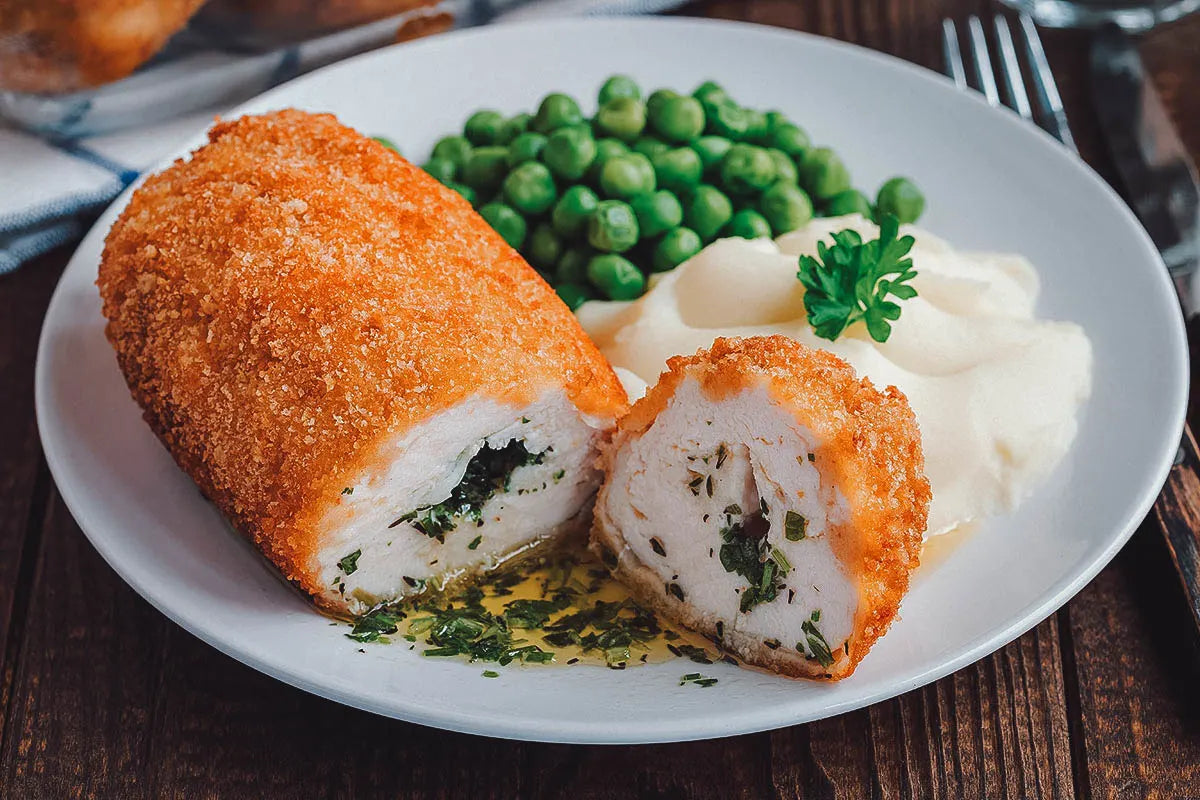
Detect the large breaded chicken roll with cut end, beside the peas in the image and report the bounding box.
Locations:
[98,110,626,614]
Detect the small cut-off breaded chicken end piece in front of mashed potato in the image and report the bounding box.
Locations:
[592,336,930,679]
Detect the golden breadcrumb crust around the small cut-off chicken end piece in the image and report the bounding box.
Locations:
[592,336,931,680]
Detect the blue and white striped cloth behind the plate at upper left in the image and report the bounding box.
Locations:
[0,0,685,275]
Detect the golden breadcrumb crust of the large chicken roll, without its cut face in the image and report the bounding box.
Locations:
[97,110,626,594]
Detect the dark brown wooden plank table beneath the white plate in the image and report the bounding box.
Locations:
[0,0,1200,800]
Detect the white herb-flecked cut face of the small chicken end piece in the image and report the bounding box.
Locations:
[598,378,859,666]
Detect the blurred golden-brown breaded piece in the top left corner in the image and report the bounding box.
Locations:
[0,0,204,92]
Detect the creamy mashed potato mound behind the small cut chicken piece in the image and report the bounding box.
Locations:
[577,215,1092,535]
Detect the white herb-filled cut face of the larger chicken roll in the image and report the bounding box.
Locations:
[316,390,602,614]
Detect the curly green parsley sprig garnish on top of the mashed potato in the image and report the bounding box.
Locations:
[796,215,917,342]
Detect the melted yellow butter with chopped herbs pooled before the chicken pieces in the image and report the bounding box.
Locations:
[364,554,720,672]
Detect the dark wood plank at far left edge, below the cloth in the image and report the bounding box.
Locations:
[0,251,65,753]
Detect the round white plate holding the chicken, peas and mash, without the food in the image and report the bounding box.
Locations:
[37,19,1187,742]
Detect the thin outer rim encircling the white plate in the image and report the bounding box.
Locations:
[34,17,1190,744]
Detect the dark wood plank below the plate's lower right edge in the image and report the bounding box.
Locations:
[772,618,1074,799]
